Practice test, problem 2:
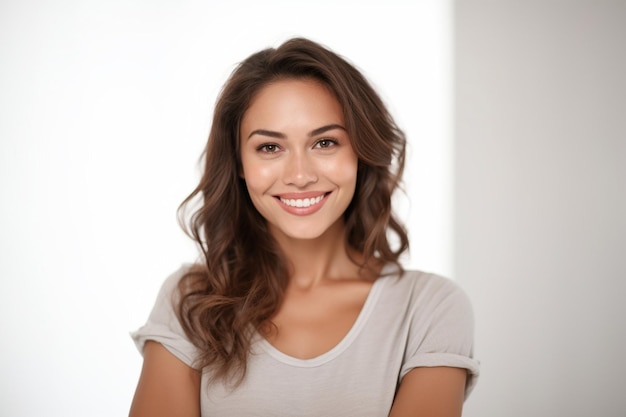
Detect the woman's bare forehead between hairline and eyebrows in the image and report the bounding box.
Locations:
[241,79,344,133]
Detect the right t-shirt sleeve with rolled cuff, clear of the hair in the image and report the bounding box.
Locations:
[400,275,480,398]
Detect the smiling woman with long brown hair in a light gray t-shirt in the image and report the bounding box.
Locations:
[130,39,478,417]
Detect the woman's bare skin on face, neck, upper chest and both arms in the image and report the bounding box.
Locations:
[130,80,467,417]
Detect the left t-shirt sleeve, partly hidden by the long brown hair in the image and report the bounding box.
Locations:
[131,266,197,367]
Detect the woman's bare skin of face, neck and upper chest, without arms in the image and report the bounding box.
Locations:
[241,80,373,358]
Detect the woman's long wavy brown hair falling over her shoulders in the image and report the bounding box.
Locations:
[177,38,408,382]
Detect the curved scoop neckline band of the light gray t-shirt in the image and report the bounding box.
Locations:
[256,264,393,368]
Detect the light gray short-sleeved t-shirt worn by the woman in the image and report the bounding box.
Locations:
[132,265,479,417]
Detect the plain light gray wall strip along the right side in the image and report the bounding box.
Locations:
[455,0,626,417]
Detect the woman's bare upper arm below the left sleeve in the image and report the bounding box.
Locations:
[129,341,201,417]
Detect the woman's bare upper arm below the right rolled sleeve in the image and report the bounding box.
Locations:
[389,366,467,417]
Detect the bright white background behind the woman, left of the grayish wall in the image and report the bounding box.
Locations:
[0,0,453,417]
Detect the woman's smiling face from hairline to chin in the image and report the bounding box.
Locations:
[240,79,358,239]
